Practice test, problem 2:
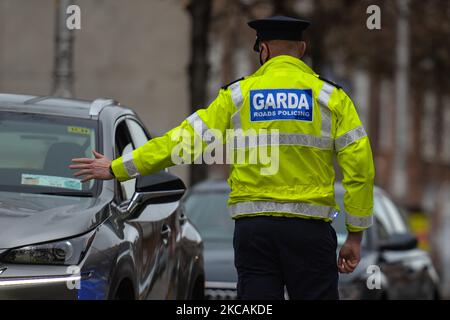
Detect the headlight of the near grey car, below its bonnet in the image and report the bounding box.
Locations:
[0,231,95,265]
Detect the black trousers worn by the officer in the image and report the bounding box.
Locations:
[233,216,339,300]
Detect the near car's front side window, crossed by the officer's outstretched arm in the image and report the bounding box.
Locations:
[115,121,136,201]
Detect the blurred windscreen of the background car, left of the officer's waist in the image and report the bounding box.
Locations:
[185,191,234,241]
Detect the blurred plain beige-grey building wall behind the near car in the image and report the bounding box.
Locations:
[0,0,190,180]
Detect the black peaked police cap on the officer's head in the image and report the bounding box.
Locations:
[248,16,311,52]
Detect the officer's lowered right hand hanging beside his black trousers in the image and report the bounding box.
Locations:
[338,232,362,273]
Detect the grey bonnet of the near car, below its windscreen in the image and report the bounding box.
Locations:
[0,191,112,249]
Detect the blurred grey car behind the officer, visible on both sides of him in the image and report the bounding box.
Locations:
[183,181,439,299]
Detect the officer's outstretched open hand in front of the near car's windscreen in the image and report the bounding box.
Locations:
[69,150,114,182]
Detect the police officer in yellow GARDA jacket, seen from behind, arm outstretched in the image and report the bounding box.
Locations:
[71,16,374,299]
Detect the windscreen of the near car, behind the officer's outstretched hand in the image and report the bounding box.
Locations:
[0,112,101,196]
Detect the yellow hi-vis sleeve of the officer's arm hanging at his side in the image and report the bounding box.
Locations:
[335,89,375,232]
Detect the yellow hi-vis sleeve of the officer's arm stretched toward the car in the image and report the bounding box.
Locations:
[111,89,235,181]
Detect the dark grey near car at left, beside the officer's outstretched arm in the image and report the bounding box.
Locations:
[0,94,204,300]
